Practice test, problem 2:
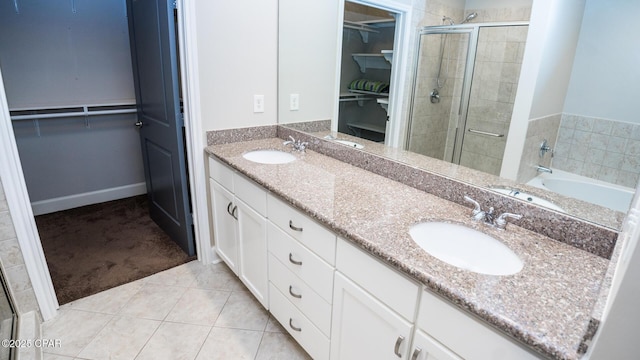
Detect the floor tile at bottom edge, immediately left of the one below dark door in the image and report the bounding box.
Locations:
[78,316,160,360]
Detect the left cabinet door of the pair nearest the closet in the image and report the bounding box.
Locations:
[209,179,238,274]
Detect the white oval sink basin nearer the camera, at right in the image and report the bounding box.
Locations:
[409,222,523,275]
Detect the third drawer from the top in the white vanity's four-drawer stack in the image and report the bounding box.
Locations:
[269,254,331,337]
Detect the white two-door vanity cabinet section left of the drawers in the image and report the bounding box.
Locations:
[209,158,269,308]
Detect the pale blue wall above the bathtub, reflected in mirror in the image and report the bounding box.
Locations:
[564,0,640,123]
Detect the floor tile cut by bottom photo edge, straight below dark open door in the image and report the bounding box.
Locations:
[136,322,211,360]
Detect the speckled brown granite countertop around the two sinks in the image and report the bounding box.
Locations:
[206,138,609,359]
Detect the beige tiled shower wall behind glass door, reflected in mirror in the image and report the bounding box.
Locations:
[409,1,531,174]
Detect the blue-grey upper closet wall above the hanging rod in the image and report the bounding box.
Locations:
[0,0,135,109]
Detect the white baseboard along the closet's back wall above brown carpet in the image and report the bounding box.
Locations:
[31,182,147,215]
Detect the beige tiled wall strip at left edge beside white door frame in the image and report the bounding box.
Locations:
[0,182,39,314]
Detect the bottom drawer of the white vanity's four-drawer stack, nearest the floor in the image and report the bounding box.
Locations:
[269,284,329,360]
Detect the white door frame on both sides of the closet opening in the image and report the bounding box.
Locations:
[0,0,212,321]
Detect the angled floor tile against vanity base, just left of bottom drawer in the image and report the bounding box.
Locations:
[215,291,269,331]
